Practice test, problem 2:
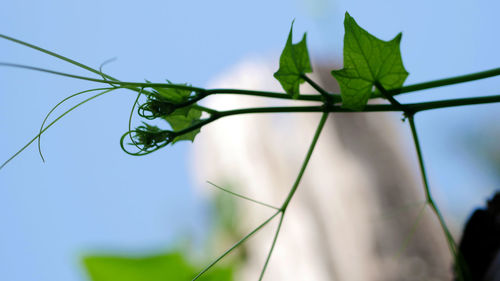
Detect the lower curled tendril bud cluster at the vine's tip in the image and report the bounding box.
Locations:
[120,122,175,156]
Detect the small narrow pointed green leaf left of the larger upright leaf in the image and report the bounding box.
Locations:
[274,22,312,99]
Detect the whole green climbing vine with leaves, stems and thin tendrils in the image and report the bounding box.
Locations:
[0,10,500,280]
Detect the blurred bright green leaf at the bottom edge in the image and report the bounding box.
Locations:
[84,252,233,281]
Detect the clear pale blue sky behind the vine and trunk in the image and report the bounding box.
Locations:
[0,0,500,281]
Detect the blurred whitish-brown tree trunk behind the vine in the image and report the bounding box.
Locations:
[189,59,452,281]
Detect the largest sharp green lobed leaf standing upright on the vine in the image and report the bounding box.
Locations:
[332,13,408,110]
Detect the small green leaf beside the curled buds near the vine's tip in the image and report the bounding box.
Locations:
[163,106,201,144]
